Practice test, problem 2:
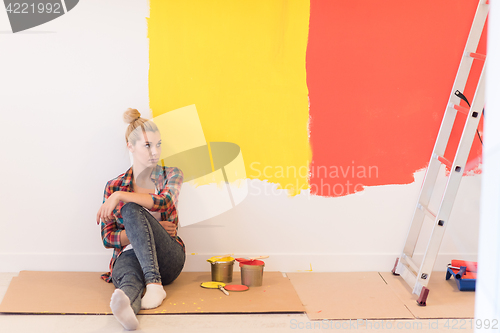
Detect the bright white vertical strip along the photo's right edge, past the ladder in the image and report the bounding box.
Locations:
[475,1,500,326]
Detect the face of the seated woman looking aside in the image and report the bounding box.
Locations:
[127,131,161,168]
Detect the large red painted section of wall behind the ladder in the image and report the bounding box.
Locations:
[306,0,487,196]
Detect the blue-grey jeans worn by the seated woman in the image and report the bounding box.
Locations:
[112,202,186,314]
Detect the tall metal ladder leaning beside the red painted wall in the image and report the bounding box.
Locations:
[392,0,489,306]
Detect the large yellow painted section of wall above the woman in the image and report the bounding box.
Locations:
[148,0,311,195]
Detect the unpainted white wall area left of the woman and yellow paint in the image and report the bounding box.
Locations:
[0,0,149,271]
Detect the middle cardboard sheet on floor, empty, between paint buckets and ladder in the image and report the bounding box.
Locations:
[287,272,414,320]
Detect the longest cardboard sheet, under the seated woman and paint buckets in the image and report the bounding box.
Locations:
[0,271,305,314]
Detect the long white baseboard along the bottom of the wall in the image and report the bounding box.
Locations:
[0,252,477,272]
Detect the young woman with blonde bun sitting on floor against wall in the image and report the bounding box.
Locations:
[97,109,186,330]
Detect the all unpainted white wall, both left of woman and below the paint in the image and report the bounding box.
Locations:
[0,0,481,271]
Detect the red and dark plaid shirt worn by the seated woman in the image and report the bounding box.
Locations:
[101,166,186,283]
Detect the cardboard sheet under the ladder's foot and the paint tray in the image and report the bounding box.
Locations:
[380,272,475,319]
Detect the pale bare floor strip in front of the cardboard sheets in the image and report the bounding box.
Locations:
[0,272,473,333]
